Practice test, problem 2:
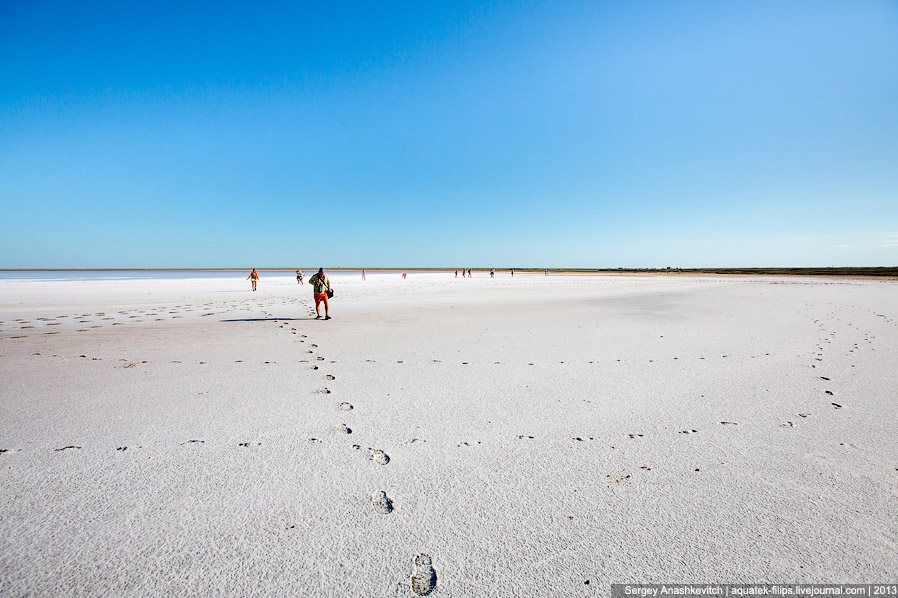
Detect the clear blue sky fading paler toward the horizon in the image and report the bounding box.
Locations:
[0,0,898,268]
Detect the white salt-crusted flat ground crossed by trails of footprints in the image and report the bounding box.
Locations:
[0,272,898,596]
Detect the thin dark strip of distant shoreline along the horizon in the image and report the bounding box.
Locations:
[0,267,898,278]
